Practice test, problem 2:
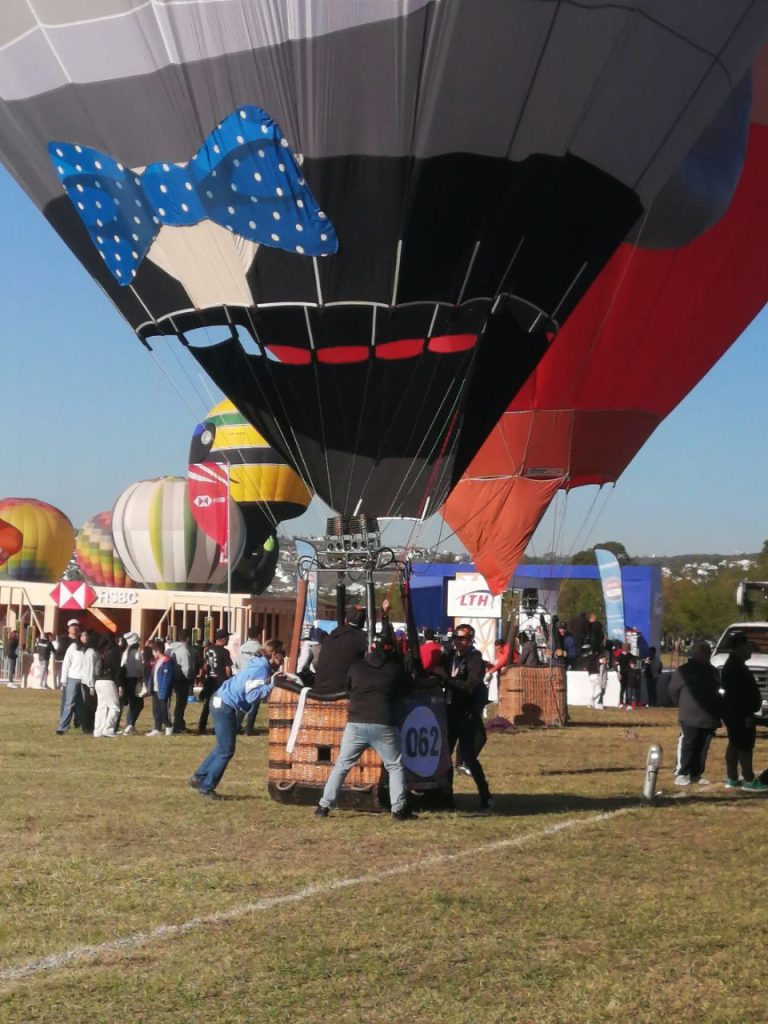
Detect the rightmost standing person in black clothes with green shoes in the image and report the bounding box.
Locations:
[720,630,768,791]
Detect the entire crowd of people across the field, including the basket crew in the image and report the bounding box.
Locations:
[6,602,768,806]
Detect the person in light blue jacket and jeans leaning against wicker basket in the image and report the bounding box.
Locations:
[189,630,285,800]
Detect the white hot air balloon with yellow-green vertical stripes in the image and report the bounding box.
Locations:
[112,476,245,590]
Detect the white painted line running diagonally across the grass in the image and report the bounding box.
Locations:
[0,804,643,984]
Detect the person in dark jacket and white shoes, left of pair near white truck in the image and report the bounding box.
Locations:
[668,640,720,785]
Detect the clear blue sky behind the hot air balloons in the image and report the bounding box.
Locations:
[0,169,768,555]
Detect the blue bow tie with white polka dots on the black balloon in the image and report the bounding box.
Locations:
[48,106,339,285]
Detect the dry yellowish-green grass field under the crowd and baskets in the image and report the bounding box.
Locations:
[0,688,768,1024]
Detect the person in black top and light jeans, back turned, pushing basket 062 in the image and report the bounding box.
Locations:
[314,601,415,821]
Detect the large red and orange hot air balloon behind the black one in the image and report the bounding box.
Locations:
[443,50,768,592]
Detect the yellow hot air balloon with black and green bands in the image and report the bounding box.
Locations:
[189,399,311,553]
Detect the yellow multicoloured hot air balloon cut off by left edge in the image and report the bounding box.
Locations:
[0,498,75,583]
